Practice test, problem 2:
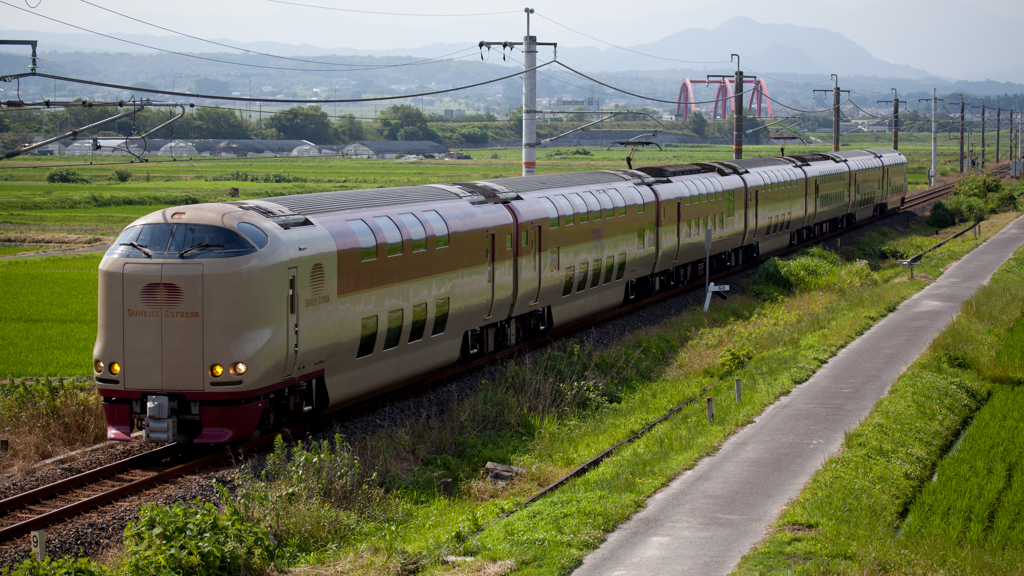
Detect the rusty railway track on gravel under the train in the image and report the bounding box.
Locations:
[0,168,987,542]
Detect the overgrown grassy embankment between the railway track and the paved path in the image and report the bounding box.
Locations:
[2,187,1009,574]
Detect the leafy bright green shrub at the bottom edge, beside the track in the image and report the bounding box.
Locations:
[124,501,274,576]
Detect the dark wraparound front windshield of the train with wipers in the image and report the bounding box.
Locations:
[106,223,257,259]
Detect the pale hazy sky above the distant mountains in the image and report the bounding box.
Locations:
[0,0,1024,79]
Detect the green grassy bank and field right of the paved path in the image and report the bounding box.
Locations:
[738,235,1024,575]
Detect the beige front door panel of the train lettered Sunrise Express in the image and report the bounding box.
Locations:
[122,262,205,390]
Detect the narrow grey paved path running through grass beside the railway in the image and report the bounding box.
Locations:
[574,218,1024,576]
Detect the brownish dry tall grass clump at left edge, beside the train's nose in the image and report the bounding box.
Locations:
[0,378,106,474]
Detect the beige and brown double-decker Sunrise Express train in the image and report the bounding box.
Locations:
[93,149,907,444]
